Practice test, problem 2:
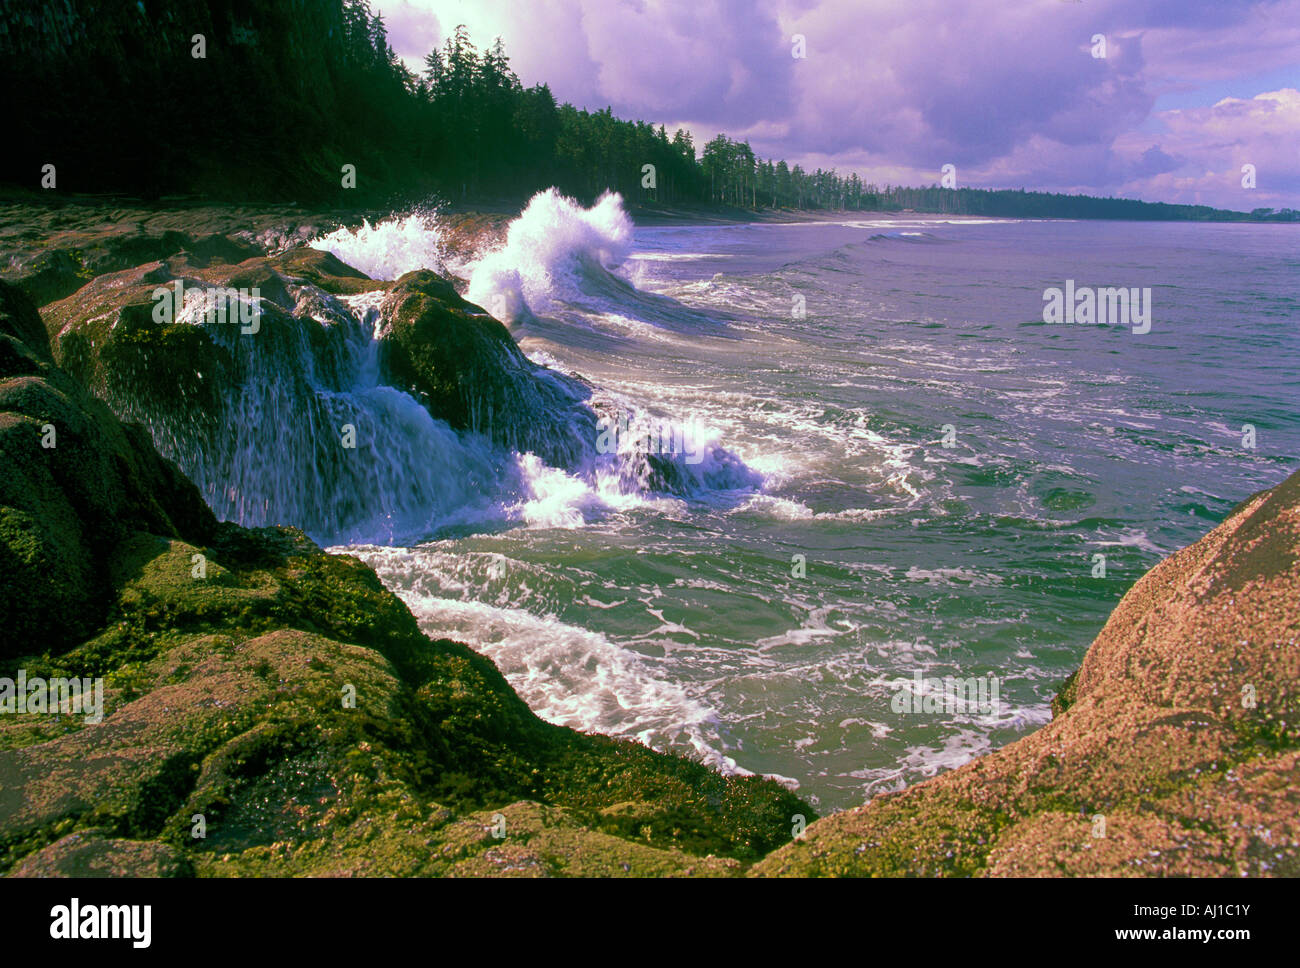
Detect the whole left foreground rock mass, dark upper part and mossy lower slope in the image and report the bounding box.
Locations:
[0,283,811,876]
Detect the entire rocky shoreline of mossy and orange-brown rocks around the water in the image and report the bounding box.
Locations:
[0,208,1300,876]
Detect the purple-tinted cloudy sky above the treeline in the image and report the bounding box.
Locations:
[371,0,1300,209]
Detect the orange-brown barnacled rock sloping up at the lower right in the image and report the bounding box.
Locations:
[754,474,1300,877]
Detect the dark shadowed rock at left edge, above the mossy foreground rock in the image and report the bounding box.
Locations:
[0,283,216,657]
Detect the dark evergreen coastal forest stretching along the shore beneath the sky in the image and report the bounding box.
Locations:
[0,0,1300,221]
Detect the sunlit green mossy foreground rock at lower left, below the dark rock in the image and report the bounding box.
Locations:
[0,526,806,874]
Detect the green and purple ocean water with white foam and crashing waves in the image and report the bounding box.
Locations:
[306,192,1300,812]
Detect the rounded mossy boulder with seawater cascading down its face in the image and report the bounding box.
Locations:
[32,247,597,542]
